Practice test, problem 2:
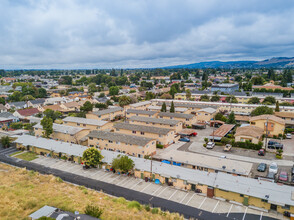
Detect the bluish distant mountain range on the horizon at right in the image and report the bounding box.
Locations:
[164,57,294,69]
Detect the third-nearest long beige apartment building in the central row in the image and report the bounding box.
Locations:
[129,116,183,133]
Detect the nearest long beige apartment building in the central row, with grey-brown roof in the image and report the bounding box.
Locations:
[88,130,156,157]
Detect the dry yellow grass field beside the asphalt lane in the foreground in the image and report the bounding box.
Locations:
[0,163,184,220]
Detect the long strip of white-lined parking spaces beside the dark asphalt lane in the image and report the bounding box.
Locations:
[32,156,283,220]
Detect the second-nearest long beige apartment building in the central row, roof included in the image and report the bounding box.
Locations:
[113,123,179,146]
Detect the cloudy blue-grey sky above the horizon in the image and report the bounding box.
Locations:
[0,0,294,69]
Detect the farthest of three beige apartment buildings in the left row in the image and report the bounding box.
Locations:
[86,107,124,121]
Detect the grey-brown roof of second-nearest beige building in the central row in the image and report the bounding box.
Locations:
[113,123,172,135]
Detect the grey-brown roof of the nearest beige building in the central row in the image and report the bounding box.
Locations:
[88,130,155,146]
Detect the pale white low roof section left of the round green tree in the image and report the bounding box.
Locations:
[14,135,88,157]
